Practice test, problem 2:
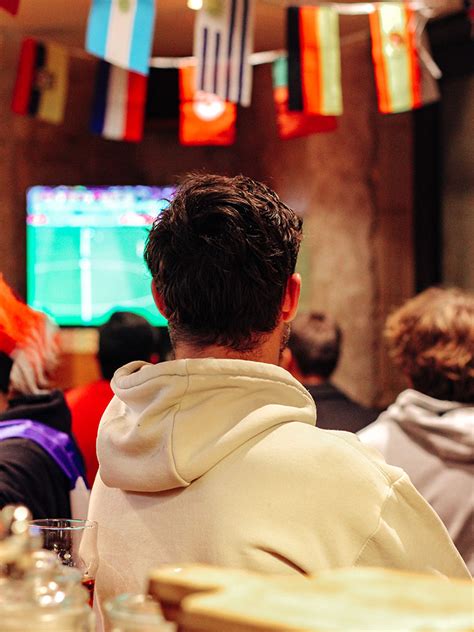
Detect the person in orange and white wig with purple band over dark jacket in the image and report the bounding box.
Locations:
[0,275,89,518]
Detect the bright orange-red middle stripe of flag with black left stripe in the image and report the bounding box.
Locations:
[300,7,322,113]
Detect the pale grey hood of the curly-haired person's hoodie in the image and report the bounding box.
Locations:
[379,389,474,463]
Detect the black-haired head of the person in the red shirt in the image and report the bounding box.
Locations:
[98,312,154,380]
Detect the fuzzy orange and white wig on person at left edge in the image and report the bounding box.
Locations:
[0,275,59,405]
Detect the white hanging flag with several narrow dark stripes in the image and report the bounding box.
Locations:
[194,0,254,106]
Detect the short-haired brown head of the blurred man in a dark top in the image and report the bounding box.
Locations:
[288,312,342,380]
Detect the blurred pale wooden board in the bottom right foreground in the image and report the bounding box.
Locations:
[149,565,474,632]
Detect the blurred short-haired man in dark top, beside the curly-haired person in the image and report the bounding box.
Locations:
[282,312,378,432]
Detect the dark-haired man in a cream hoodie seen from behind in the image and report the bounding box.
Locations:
[89,175,469,624]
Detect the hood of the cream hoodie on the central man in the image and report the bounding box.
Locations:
[97,358,316,492]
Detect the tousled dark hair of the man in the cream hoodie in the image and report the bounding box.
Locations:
[145,175,302,352]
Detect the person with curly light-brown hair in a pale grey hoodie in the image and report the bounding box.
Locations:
[359,288,474,573]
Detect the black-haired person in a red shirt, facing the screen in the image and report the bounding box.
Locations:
[66,312,155,487]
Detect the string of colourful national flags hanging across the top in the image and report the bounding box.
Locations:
[7,0,446,145]
